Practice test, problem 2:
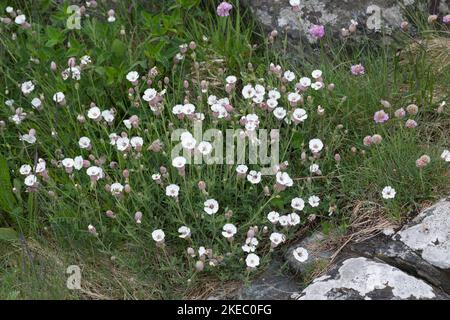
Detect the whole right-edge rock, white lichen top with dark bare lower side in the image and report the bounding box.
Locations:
[348,200,450,293]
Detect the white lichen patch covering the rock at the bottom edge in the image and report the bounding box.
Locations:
[299,257,435,300]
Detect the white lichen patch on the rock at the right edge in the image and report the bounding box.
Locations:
[398,201,450,269]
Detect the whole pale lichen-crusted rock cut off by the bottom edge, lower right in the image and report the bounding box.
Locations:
[299,257,448,300]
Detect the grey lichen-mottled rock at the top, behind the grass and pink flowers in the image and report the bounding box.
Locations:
[243,0,440,43]
